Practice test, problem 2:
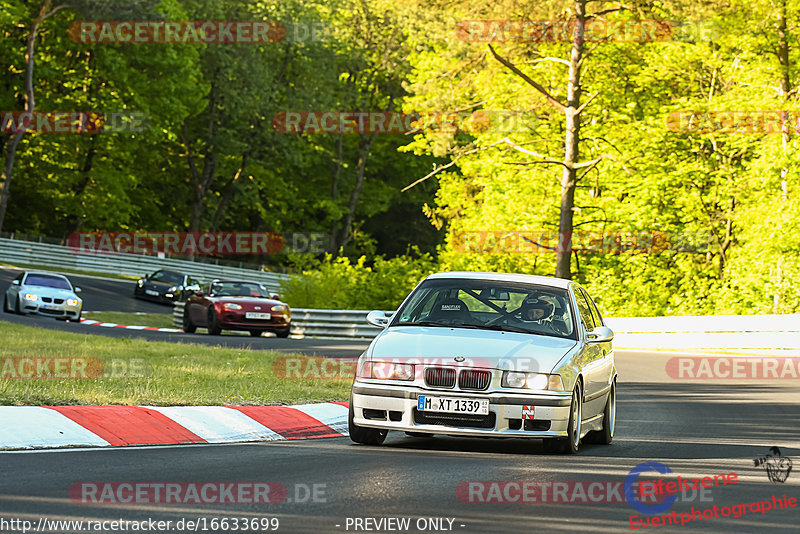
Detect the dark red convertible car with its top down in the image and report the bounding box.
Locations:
[183,280,292,337]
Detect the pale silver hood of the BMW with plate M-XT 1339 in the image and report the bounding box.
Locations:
[370,326,577,373]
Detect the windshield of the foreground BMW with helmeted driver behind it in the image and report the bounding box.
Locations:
[390,278,576,339]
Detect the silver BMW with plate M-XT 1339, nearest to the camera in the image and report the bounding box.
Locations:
[349,272,617,454]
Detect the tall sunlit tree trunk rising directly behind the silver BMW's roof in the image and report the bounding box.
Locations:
[556,0,586,279]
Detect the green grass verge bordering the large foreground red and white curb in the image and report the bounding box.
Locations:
[0,322,351,406]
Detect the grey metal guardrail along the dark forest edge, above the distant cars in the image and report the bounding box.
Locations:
[0,238,289,290]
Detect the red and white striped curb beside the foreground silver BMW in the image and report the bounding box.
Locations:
[0,402,348,449]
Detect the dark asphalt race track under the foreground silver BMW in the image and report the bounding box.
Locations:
[0,348,800,533]
